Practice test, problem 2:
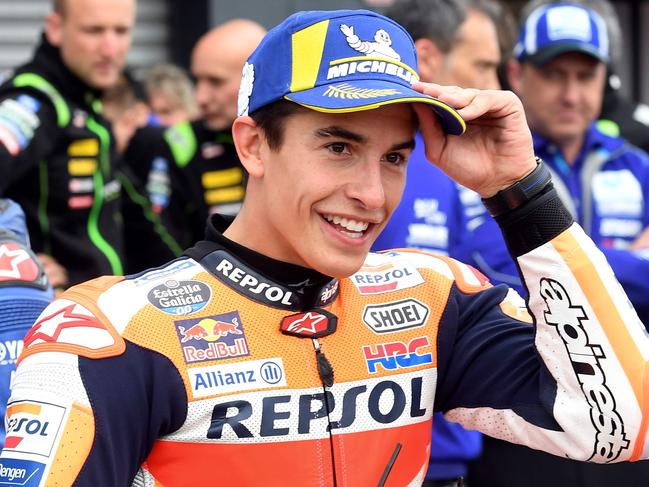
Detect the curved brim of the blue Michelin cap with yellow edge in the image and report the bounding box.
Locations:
[284,80,466,135]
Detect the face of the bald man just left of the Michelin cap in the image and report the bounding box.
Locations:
[191,44,243,130]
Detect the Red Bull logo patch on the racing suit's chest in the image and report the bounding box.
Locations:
[174,311,250,364]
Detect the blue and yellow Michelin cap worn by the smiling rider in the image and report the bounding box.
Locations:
[238,10,466,135]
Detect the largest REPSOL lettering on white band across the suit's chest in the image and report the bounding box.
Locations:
[207,376,434,441]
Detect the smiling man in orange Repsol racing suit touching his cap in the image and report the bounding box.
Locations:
[1,10,649,487]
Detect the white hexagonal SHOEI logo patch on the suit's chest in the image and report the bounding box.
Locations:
[363,299,429,333]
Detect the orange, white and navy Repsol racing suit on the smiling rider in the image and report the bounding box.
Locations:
[0,184,649,487]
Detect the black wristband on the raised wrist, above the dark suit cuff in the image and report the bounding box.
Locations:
[482,157,552,218]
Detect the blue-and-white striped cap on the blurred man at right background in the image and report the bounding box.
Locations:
[514,3,610,66]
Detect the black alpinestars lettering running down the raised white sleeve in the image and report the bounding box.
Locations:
[540,279,629,463]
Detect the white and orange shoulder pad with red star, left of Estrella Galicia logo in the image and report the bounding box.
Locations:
[19,278,126,361]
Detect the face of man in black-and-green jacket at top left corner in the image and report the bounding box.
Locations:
[47,0,135,89]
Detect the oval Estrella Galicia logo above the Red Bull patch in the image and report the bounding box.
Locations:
[147,279,212,315]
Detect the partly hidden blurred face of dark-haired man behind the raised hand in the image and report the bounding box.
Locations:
[433,10,500,89]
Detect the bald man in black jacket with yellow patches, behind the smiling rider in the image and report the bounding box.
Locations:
[127,19,266,266]
